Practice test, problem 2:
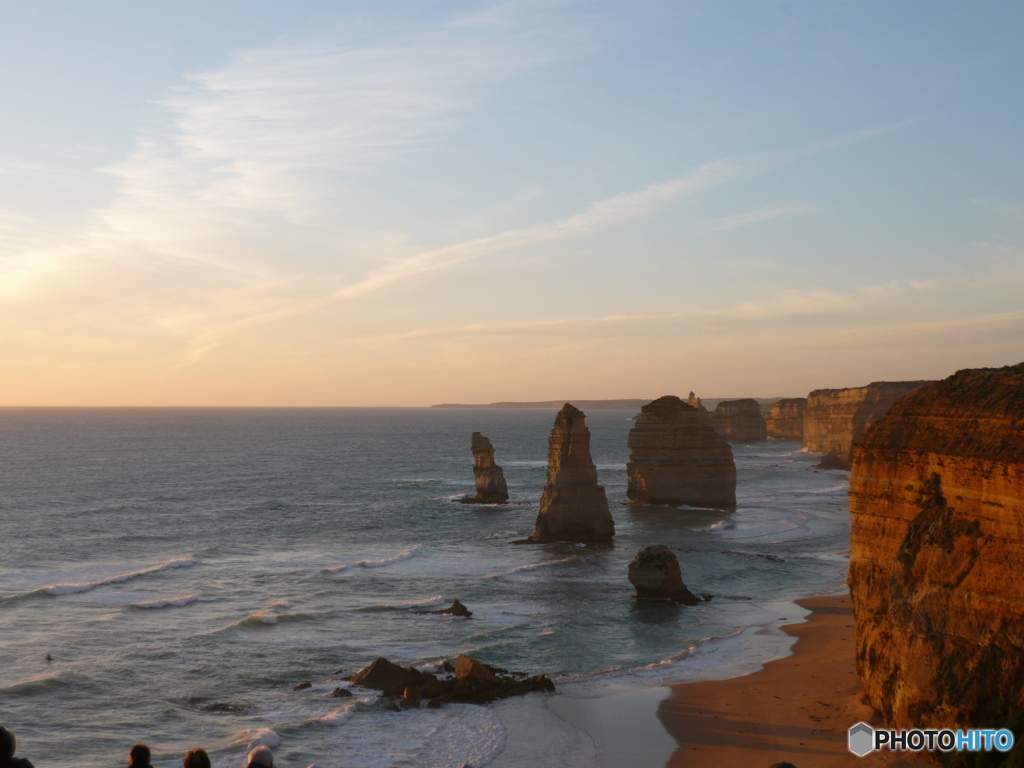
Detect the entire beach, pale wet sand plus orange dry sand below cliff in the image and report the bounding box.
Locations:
[551,594,934,768]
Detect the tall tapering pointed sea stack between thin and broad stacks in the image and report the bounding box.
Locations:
[528,402,615,542]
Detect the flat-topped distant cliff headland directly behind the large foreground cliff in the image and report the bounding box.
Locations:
[803,381,931,469]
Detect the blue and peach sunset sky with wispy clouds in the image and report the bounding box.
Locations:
[0,0,1024,407]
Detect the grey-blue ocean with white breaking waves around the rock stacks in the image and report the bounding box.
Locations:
[0,409,849,768]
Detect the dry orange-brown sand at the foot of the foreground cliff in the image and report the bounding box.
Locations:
[657,595,933,768]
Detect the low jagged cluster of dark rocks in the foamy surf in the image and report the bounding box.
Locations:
[342,653,555,709]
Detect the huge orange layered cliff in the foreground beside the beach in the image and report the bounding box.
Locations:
[849,362,1024,728]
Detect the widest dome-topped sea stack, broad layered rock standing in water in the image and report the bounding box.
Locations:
[626,395,736,507]
